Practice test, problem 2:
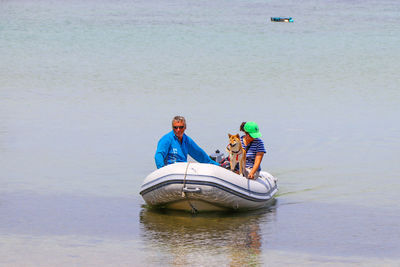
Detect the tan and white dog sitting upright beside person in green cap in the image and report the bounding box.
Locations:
[226,134,246,176]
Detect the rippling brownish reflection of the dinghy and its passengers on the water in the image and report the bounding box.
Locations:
[140,205,275,266]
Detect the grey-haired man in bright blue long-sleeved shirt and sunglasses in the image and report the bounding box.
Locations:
[154,116,219,169]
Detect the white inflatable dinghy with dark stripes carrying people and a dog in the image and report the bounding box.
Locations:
[140,162,278,212]
